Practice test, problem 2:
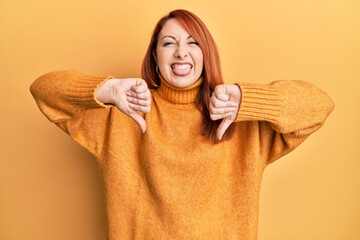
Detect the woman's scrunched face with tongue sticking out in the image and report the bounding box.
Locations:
[154,19,203,88]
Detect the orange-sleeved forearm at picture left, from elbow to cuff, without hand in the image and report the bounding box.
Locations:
[30,71,107,123]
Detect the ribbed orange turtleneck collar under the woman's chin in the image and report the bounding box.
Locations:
[157,74,202,104]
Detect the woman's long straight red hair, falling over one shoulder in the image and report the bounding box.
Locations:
[141,9,233,142]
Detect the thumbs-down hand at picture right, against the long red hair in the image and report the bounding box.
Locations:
[209,84,241,140]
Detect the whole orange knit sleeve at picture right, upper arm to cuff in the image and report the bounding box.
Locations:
[236,80,334,164]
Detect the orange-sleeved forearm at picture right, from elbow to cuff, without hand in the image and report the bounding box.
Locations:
[237,81,334,132]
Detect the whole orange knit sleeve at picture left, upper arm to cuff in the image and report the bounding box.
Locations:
[30,71,116,157]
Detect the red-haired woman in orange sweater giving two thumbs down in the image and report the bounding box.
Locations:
[31,10,333,240]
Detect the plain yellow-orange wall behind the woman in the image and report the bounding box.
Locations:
[0,0,360,240]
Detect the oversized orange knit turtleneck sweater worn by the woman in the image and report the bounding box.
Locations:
[31,71,334,240]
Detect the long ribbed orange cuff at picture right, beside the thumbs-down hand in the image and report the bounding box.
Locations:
[236,83,283,122]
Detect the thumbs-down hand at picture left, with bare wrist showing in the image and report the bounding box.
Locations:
[95,78,151,132]
